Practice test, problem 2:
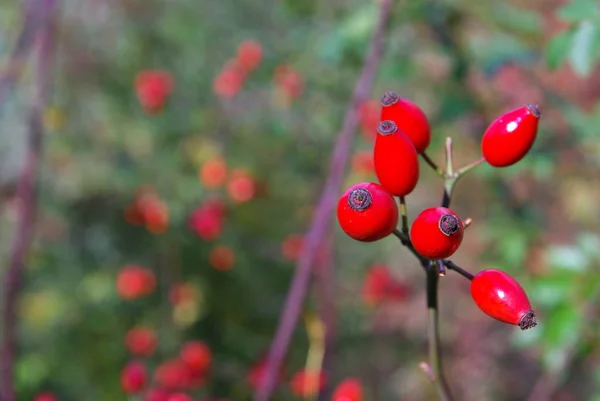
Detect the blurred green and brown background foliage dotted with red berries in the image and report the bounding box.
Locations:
[0,0,600,401]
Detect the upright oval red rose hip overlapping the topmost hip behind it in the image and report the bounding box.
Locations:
[373,120,419,196]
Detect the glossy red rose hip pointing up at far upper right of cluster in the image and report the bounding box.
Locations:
[481,104,542,167]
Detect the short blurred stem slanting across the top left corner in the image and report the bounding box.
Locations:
[0,0,54,108]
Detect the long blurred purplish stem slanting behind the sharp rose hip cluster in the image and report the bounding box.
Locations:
[254,0,392,401]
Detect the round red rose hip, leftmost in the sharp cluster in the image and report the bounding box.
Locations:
[337,182,398,242]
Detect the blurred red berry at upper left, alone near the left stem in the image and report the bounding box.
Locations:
[134,70,173,114]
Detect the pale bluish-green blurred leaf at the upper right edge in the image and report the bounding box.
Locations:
[569,20,600,77]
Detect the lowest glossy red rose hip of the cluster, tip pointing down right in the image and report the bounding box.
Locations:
[471,269,537,330]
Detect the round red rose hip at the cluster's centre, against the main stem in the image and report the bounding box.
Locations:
[410,207,464,259]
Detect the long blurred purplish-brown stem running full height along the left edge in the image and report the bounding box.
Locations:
[0,0,58,401]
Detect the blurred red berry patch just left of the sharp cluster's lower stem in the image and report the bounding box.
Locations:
[362,265,408,305]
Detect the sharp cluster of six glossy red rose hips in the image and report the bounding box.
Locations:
[337,92,541,330]
